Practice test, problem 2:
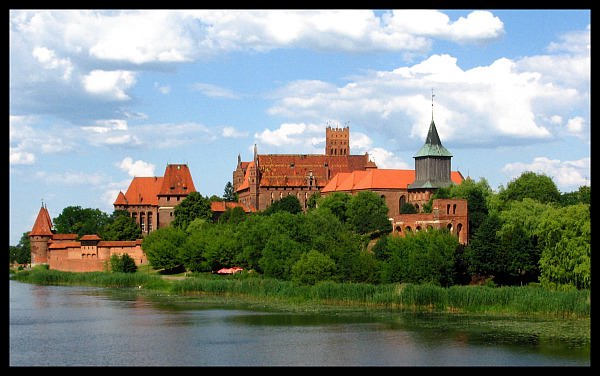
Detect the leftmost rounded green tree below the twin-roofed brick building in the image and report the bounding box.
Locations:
[142,227,187,271]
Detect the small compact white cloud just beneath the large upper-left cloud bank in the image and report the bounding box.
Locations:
[83,70,135,101]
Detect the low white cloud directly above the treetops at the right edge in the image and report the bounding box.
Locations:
[502,157,591,192]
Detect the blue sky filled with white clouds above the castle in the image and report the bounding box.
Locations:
[9,9,591,245]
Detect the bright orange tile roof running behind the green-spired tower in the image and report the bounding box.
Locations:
[321,169,464,193]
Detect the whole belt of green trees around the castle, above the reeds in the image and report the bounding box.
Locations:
[11,172,591,289]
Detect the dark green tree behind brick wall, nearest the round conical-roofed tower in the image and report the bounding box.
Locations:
[53,206,110,237]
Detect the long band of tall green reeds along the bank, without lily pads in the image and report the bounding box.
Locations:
[10,270,591,318]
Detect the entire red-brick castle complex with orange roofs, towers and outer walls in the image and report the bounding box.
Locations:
[29,108,469,272]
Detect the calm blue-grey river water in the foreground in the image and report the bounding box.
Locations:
[9,280,590,366]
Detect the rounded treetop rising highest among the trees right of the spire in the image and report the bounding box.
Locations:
[499,171,560,204]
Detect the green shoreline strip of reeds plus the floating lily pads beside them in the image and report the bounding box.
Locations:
[9,267,591,348]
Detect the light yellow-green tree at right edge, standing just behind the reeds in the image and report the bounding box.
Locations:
[537,204,592,288]
